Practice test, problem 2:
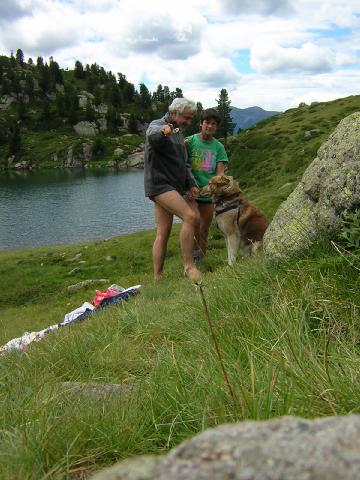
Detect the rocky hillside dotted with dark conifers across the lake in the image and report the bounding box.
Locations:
[0,50,188,170]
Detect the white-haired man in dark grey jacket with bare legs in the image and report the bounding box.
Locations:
[144,98,200,282]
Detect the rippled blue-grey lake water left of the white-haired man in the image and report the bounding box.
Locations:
[0,169,158,250]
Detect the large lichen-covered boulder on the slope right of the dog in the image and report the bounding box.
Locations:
[264,113,360,260]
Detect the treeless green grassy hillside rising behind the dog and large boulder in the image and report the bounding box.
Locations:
[228,95,360,217]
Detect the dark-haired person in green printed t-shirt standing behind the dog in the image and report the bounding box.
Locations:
[185,108,228,260]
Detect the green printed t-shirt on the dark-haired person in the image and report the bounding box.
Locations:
[187,134,228,203]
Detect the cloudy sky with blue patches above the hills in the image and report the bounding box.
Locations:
[0,0,360,110]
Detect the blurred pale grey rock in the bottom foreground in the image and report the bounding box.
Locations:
[93,415,360,480]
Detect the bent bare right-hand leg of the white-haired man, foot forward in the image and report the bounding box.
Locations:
[154,190,200,278]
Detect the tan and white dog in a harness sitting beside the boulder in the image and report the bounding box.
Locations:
[200,175,269,265]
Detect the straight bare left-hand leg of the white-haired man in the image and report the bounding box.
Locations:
[152,202,173,280]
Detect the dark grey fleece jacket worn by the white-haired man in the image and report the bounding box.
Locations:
[144,113,196,197]
